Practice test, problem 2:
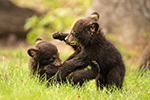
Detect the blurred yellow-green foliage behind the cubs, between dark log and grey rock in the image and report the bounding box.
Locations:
[12,0,92,44]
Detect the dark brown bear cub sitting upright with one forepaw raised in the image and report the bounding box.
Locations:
[53,12,125,89]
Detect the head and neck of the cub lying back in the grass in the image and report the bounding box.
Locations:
[27,38,62,80]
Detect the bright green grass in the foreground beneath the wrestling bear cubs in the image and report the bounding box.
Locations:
[0,49,150,100]
